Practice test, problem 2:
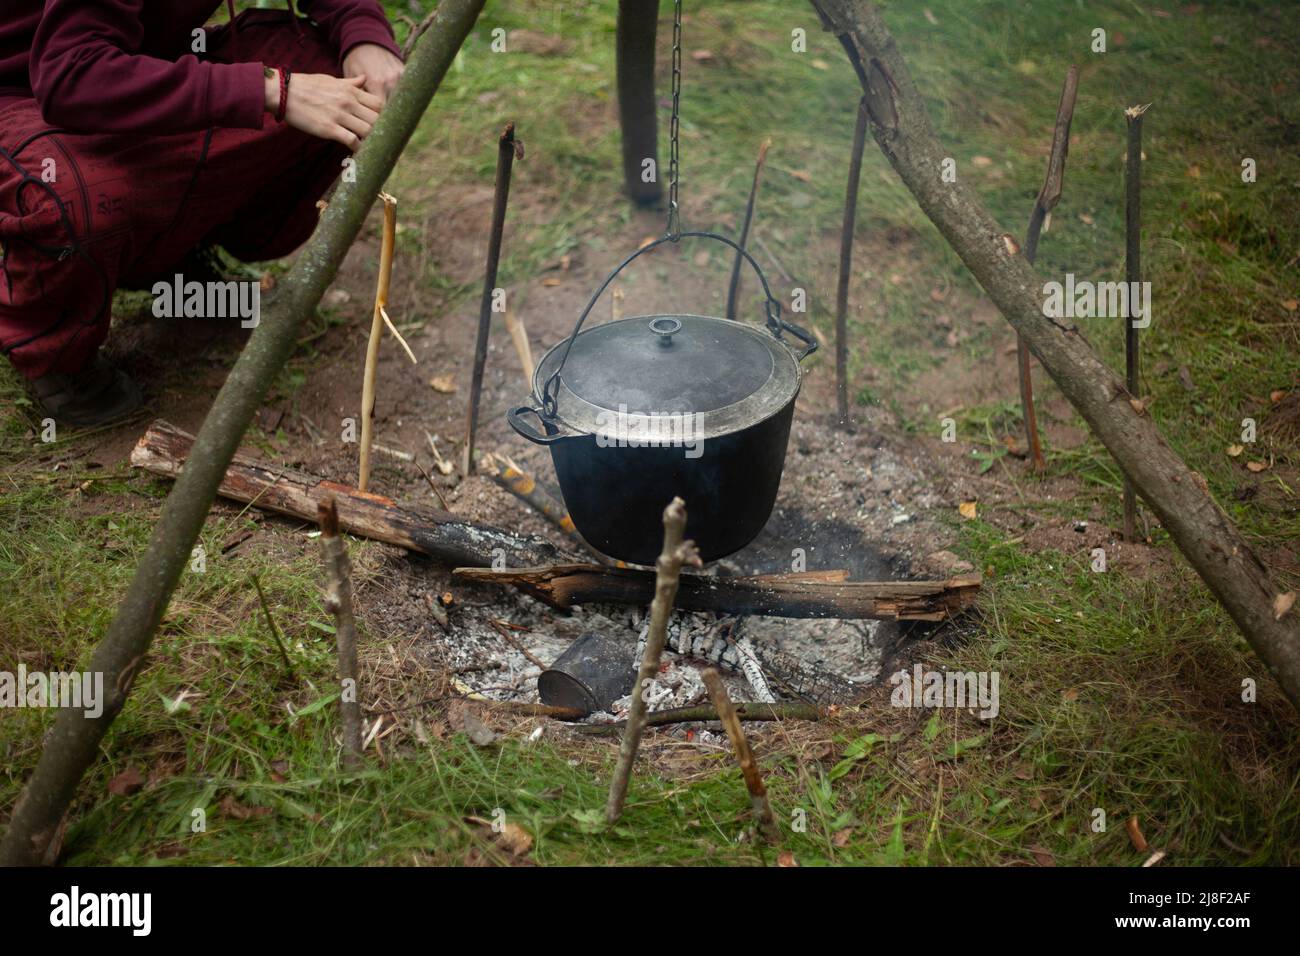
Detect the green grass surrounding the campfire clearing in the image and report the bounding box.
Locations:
[0,0,1300,865]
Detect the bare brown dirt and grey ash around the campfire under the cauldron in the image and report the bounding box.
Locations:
[58,189,1180,733]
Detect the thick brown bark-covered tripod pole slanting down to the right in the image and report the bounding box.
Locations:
[811,0,1300,706]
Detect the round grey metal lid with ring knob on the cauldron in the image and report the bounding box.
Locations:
[533,315,801,437]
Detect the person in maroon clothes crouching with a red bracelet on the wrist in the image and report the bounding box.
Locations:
[0,0,402,427]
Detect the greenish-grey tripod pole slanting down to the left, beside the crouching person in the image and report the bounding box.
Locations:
[0,0,485,865]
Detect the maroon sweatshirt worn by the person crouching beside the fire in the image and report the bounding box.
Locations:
[0,0,399,134]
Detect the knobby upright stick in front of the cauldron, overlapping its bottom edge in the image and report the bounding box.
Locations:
[605,498,702,823]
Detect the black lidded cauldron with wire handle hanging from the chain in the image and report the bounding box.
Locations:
[507,233,816,564]
